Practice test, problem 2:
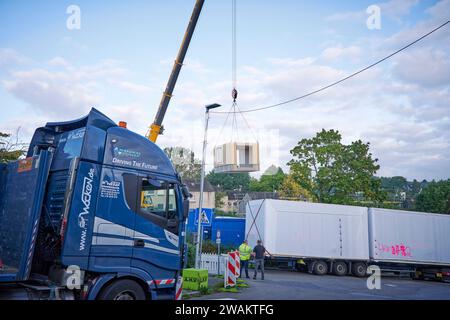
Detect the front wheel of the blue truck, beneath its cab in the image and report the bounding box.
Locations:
[98,279,145,300]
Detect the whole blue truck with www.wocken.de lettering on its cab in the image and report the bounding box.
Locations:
[0,109,189,300]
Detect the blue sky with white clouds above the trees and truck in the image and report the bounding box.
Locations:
[0,0,450,179]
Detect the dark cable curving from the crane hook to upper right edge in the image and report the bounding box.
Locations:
[211,20,450,113]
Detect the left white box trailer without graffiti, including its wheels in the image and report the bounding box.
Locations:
[246,199,369,276]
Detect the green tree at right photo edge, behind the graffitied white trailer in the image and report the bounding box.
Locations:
[416,179,450,214]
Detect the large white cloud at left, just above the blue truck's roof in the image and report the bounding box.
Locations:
[2,57,157,117]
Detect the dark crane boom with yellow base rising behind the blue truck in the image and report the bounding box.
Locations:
[147,0,205,142]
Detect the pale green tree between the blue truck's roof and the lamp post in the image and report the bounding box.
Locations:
[164,147,202,181]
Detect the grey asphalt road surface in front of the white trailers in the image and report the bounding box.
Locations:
[197,270,450,300]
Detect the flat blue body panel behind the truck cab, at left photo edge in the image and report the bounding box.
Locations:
[0,150,53,282]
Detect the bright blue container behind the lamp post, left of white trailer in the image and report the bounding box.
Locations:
[187,209,245,247]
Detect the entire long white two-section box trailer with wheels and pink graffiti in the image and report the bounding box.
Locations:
[246,199,450,281]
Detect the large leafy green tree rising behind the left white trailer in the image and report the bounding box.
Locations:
[288,129,386,204]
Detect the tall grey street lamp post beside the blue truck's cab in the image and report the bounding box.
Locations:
[195,103,220,269]
